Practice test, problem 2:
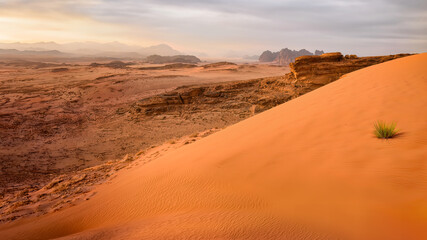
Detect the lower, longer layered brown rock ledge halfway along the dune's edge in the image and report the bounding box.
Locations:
[130,77,296,118]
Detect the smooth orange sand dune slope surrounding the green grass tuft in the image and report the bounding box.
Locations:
[0,54,427,239]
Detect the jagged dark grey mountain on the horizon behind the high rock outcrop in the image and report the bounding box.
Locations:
[258,48,324,65]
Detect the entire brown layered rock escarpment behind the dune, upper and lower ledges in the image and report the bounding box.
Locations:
[133,53,408,120]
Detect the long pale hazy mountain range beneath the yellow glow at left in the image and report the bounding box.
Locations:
[0,42,182,58]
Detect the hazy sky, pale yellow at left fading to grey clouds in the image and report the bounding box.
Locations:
[0,0,427,56]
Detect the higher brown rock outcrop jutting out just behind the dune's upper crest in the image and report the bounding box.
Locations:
[287,52,409,90]
